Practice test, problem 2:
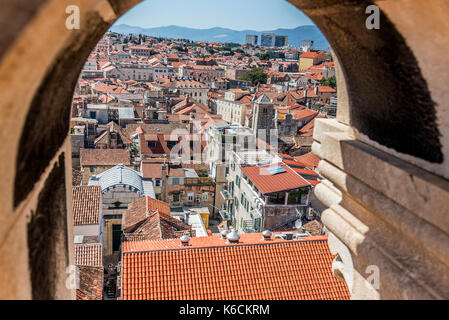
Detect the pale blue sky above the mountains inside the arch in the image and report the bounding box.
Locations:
[116,0,313,31]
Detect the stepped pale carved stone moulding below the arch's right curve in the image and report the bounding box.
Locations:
[312,119,449,299]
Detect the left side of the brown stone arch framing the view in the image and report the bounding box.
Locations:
[0,0,139,299]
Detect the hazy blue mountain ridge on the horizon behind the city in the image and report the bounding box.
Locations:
[109,24,329,49]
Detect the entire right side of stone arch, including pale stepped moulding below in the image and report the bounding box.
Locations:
[291,0,449,299]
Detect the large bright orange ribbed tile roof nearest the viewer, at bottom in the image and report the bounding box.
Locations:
[122,233,350,300]
